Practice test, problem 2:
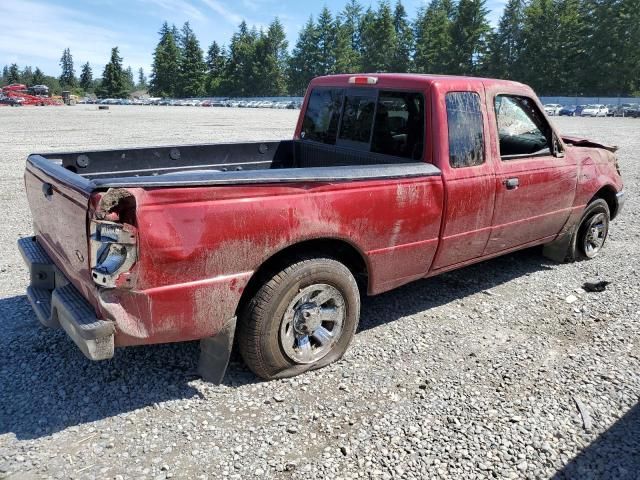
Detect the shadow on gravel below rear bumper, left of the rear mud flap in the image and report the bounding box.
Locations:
[0,290,215,440]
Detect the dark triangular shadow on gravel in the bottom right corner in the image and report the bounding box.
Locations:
[552,403,640,480]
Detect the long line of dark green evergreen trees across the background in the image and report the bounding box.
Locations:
[3,0,640,97]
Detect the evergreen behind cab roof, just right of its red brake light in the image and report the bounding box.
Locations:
[360,0,398,72]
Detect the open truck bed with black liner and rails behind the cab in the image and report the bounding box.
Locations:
[28,140,440,192]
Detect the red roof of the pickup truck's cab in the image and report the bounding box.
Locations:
[309,73,531,91]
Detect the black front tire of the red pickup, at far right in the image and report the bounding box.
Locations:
[567,198,611,262]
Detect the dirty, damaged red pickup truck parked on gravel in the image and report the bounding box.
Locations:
[18,74,624,381]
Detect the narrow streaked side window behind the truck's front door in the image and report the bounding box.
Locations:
[446,92,484,168]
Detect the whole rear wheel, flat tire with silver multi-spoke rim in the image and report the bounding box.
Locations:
[238,258,360,380]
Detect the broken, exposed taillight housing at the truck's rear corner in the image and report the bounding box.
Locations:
[89,220,137,288]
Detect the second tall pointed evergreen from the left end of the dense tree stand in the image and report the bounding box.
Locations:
[178,22,206,97]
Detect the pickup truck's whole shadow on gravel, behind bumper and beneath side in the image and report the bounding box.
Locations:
[0,249,550,439]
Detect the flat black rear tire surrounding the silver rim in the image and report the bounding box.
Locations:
[237,258,360,380]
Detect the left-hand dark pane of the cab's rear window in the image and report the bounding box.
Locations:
[301,88,343,145]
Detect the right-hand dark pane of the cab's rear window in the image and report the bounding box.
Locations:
[371,91,424,160]
